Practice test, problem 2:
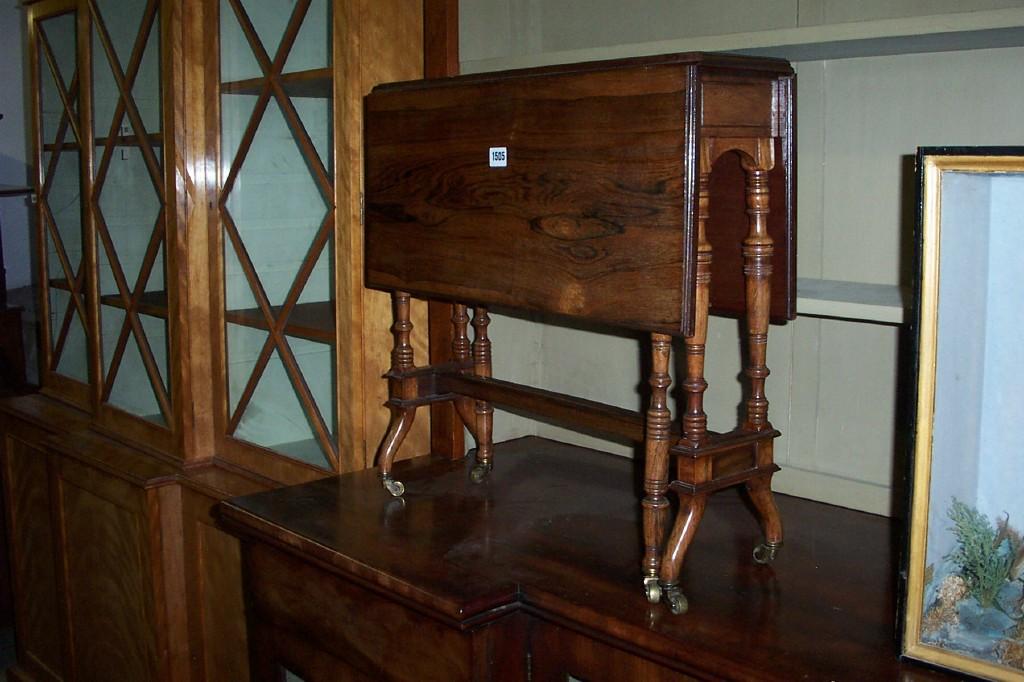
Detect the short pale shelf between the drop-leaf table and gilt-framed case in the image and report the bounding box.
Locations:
[797,278,907,325]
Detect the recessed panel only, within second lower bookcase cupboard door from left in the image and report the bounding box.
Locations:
[60,476,157,682]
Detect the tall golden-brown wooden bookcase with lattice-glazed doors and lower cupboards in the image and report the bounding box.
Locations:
[0,0,429,680]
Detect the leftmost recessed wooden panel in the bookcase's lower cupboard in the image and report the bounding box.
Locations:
[3,435,63,680]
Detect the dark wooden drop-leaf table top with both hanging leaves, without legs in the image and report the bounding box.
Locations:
[365,53,796,335]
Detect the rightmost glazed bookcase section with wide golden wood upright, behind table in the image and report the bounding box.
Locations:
[215,0,429,482]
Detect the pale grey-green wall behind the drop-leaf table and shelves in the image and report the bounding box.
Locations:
[460,0,1024,514]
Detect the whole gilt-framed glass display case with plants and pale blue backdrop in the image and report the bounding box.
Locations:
[902,147,1024,680]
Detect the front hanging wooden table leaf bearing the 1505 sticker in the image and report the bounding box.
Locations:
[366,62,687,328]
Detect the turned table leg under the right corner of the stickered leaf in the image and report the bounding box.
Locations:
[641,334,672,603]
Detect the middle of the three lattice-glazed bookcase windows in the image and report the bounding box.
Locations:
[92,0,169,424]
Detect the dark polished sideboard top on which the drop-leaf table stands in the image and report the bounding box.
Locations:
[220,437,946,680]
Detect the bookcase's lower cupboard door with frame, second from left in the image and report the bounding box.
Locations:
[53,457,187,682]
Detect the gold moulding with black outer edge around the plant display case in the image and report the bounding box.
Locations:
[902,147,1024,682]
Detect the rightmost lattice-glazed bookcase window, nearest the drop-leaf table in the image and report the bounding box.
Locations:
[220,0,338,467]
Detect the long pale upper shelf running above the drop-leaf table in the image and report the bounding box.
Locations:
[462,8,1024,74]
